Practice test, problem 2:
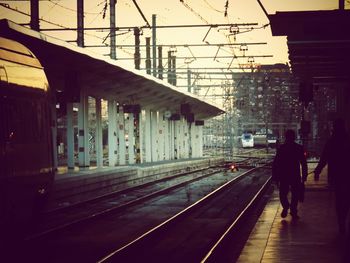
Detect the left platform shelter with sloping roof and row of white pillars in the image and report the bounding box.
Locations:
[0,20,224,169]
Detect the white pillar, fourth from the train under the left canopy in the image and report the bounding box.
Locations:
[108,100,117,166]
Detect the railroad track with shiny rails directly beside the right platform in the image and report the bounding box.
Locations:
[98,165,270,263]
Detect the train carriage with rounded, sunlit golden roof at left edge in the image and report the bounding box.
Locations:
[0,37,54,234]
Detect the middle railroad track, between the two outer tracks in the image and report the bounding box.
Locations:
[7,158,274,262]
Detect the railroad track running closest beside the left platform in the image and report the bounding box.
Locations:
[25,167,223,240]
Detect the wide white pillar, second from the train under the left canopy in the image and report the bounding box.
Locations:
[78,90,90,169]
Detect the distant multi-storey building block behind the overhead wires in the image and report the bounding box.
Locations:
[233,64,301,140]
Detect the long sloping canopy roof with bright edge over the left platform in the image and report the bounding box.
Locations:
[0,19,224,119]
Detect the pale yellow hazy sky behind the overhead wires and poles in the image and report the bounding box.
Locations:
[0,0,349,96]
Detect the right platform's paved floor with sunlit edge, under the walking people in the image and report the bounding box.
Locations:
[236,164,350,263]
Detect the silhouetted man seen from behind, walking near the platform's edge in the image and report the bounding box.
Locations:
[272,130,307,219]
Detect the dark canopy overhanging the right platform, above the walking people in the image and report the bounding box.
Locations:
[268,10,350,84]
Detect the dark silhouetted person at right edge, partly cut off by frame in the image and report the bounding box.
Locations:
[314,119,350,235]
